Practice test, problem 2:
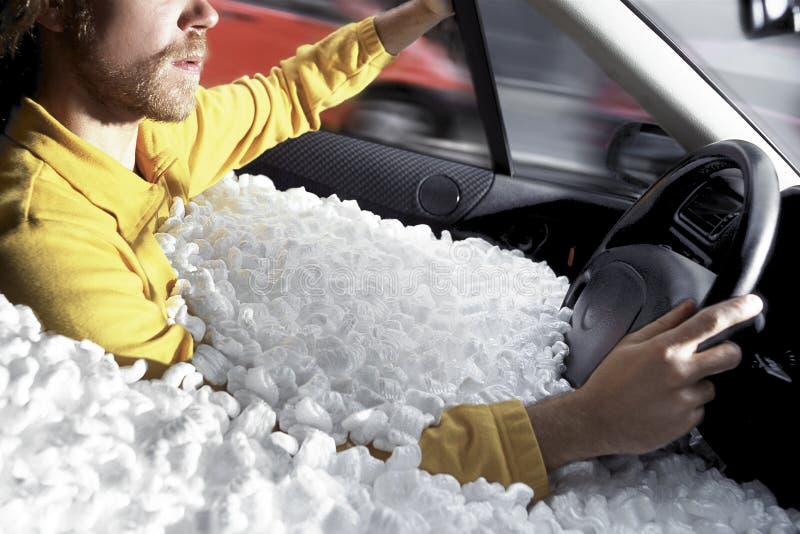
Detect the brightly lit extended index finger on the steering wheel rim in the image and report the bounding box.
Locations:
[664,295,764,347]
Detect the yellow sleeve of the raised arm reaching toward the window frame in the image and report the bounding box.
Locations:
[153,18,395,198]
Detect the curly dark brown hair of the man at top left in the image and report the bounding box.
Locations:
[0,0,91,133]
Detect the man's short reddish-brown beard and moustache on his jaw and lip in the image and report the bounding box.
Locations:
[73,34,207,122]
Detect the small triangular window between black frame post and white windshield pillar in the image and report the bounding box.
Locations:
[478,0,653,195]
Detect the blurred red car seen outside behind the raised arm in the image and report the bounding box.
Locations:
[202,0,472,135]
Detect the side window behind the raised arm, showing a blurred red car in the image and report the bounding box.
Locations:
[202,0,490,168]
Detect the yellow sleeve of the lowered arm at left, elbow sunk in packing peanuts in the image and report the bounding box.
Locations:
[0,221,193,376]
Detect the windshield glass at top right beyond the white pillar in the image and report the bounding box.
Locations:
[630,0,800,174]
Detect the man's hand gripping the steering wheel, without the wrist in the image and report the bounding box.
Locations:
[579,295,762,454]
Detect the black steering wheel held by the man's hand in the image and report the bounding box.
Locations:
[564,141,780,387]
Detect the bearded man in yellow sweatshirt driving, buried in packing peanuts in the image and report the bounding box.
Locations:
[0,0,761,506]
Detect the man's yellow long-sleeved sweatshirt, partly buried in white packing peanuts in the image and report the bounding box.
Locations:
[0,19,547,498]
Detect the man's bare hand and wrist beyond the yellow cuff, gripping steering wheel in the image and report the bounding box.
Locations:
[528,295,763,471]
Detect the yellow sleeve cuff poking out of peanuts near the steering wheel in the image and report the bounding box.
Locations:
[420,400,549,500]
